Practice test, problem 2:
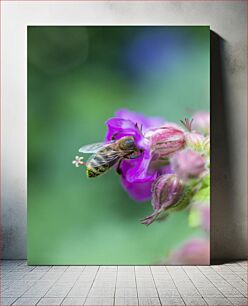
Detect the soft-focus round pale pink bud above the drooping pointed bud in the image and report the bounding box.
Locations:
[171,149,205,181]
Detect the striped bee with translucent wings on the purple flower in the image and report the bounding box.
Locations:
[79,136,143,178]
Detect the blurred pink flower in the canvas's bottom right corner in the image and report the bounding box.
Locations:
[166,238,210,265]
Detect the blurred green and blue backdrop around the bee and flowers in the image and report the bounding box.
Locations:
[28,26,210,265]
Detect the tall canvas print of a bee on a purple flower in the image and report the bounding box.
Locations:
[28,26,210,265]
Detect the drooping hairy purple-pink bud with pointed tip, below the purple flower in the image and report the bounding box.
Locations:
[141,174,184,225]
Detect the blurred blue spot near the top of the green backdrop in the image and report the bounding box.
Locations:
[123,27,190,78]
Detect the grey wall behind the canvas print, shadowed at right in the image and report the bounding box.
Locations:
[1,1,247,260]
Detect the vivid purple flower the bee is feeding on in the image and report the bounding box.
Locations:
[106,109,168,201]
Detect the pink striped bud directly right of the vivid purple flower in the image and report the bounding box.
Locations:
[146,124,185,158]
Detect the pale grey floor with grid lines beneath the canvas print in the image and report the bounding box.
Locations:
[0,261,247,306]
